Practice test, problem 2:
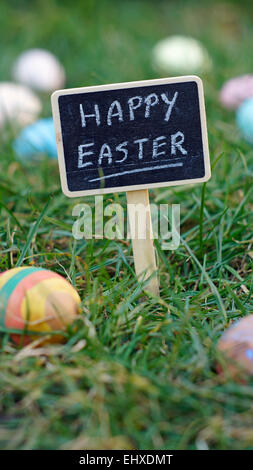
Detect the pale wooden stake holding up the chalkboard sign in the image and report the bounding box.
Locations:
[126,189,159,295]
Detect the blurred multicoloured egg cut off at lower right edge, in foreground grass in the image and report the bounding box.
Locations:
[218,315,253,376]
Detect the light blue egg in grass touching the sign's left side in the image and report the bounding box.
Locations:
[13,118,57,160]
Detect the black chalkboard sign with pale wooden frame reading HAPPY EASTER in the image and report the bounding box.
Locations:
[52,76,210,197]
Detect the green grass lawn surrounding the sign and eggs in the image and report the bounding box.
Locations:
[0,0,253,449]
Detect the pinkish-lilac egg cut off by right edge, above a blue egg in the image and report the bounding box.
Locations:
[220,75,253,109]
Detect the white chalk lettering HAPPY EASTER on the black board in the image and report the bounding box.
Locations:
[77,91,187,172]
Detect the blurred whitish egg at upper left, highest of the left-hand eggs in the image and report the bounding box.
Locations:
[13,49,65,92]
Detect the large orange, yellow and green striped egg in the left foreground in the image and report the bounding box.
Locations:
[0,267,81,344]
